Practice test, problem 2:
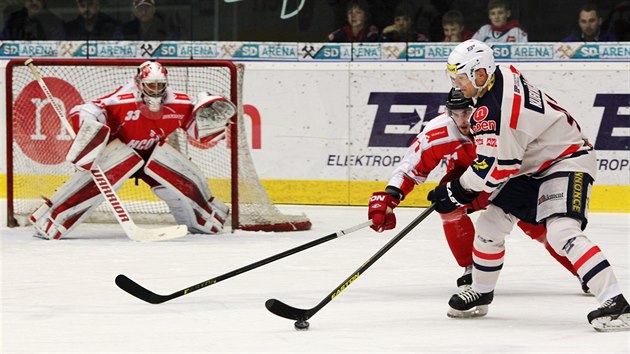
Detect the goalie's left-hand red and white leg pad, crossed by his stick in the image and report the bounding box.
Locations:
[30,140,143,240]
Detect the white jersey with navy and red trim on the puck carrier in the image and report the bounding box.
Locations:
[460,66,596,192]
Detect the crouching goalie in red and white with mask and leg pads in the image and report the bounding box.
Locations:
[30,61,236,239]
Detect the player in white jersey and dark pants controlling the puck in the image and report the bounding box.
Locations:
[428,39,630,331]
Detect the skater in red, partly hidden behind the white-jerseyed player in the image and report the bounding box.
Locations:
[368,89,577,289]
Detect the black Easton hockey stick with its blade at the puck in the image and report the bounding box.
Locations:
[265,203,435,330]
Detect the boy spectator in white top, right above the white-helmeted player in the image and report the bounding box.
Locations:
[473,0,527,43]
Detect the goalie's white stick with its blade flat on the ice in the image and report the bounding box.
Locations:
[24,59,188,241]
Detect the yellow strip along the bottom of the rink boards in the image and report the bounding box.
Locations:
[0,174,630,213]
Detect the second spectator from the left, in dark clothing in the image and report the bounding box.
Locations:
[65,0,122,40]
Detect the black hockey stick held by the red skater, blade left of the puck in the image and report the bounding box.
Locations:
[116,220,372,304]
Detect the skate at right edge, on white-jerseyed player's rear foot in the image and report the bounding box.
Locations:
[588,294,630,332]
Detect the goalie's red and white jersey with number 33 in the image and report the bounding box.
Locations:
[69,81,213,158]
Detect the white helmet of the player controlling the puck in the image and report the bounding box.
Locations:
[446,39,496,89]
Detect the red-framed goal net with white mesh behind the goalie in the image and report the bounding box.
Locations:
[6,59,311,231]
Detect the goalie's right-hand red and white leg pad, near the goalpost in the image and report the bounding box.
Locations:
[144,144,229,234]
